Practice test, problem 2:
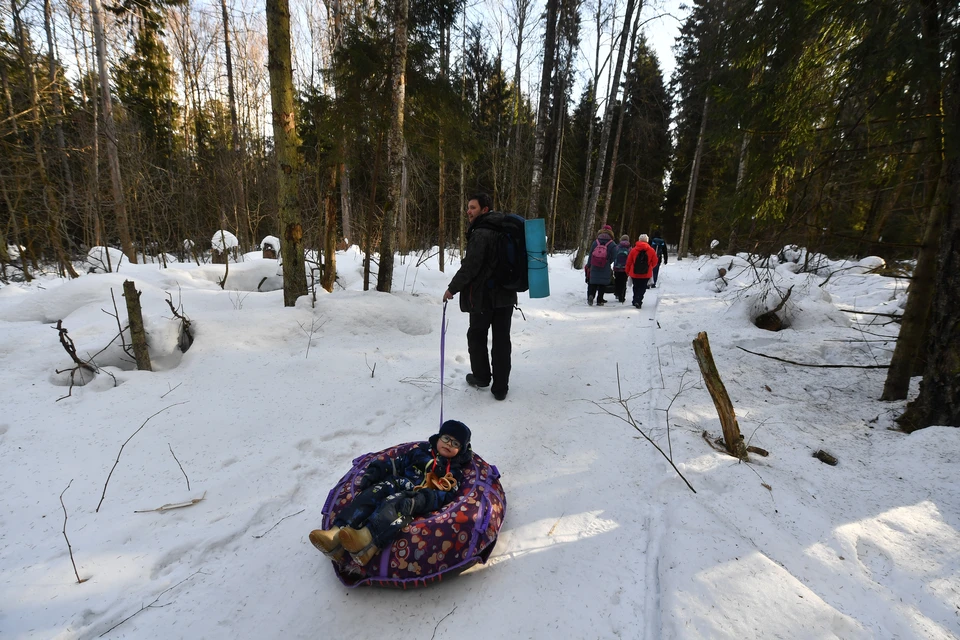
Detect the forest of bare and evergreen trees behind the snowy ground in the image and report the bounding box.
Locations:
[0,0,960,430]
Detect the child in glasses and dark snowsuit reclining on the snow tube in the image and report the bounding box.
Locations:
[310,420,473,566]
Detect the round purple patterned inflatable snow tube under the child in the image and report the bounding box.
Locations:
[323,442,507,589]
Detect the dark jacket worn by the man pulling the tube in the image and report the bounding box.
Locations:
[447,211,517,313]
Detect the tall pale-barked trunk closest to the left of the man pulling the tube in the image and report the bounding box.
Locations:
[377,0,410,293]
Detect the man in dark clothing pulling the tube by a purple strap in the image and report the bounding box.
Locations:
[443,193,517,400]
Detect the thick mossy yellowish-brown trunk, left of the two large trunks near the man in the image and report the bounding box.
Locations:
[266,0,307,307]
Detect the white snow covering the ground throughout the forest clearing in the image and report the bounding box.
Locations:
[0,247,960,639]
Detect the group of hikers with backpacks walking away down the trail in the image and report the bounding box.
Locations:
[583,224,667,309]
